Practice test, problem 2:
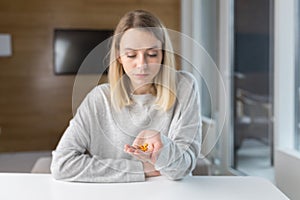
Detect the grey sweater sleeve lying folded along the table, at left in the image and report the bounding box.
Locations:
[51,86,145,182]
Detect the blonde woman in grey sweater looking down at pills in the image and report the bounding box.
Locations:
[51,10,201,182]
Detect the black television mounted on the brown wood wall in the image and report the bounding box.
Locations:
[53,29,113,75]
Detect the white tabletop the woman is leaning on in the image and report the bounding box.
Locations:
[0,173,288,200]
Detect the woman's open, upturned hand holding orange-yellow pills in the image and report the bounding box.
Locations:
[124,130,163,164]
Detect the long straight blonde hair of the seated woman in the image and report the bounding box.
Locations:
[108,10,176,111]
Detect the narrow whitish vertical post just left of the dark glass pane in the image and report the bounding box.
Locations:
[218,0,234,174]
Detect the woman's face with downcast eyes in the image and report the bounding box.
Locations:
[119,29,163,94]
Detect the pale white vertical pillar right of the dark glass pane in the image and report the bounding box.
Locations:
[274,0,296,148]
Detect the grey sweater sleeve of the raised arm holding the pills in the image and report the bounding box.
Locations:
[155,74,202,180]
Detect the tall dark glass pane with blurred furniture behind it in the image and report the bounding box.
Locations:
[231,0,274,180]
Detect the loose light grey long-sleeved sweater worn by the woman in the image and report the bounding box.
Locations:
[51,72,201,182]
